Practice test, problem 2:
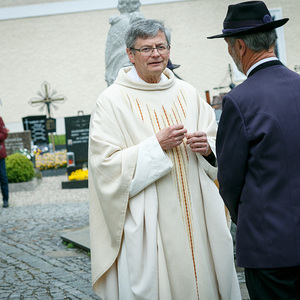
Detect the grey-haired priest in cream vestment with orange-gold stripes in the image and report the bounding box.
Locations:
[89,20,241,300]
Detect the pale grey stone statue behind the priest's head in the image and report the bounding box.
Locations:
[105,0,144,86]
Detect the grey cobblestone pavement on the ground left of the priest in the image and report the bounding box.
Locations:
[0,176,99,300]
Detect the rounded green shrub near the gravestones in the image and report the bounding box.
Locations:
[5,153,34,183]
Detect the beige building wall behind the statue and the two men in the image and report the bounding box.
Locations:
[0,0,300,131]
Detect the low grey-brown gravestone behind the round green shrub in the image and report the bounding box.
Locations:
[5,130,31,155]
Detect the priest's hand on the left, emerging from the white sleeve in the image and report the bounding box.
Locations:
[156,124,187,150]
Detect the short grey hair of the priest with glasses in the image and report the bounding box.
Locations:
[125,19,171,49]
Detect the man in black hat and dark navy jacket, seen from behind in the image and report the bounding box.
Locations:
[208,1,300,300]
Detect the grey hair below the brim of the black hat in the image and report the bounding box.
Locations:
[227,29,277,52]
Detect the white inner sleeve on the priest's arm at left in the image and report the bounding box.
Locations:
[129,135,173,197]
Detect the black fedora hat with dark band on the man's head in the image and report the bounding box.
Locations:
[207,1,289,39]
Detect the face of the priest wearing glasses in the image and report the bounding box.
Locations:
[127,31,170,83]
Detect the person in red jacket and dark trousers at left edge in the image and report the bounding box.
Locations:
[0,117,9,208]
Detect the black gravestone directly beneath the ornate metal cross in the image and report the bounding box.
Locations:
[22,116,48,146]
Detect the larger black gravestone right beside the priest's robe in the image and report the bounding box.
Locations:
[65,115,91,165]
